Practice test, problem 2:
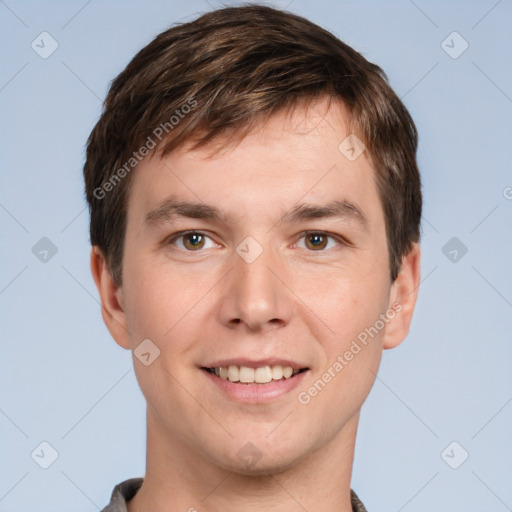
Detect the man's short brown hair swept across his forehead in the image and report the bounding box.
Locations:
[84,4,422,285]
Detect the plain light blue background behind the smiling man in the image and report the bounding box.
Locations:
[0,0,512,512]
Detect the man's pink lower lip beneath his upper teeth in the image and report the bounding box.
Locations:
[201,369,309,404]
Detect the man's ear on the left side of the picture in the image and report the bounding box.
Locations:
[91,245,130,349]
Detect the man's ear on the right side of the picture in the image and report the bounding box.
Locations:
[383,243,421,349]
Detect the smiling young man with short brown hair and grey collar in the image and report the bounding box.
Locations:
[84,5,422,512]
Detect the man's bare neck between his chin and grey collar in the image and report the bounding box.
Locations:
[128,409,359,512]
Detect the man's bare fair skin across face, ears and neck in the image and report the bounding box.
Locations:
[91,99,420,512]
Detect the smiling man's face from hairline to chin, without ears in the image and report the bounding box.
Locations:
[112,101,399,473]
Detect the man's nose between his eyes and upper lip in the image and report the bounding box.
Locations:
[218,239,294,332]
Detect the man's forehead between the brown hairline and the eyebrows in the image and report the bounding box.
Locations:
[128,100,380,234]
